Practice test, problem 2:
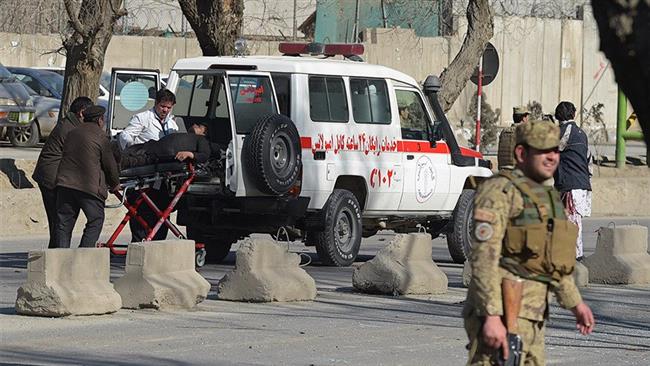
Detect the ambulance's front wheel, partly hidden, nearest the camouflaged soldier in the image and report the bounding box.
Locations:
[447,189,476,263]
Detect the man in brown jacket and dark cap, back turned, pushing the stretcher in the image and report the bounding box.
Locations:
[56,106,120,248]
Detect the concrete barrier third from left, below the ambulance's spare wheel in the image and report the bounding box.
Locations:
[218,234,316,302]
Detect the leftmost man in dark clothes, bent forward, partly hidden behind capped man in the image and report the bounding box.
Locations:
[32,97,93,248]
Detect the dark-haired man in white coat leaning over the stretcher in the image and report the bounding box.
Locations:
[118,89,178,243]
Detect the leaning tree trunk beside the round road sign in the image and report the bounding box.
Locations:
[438,0,494,112]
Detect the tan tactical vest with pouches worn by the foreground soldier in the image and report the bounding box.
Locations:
[499,171,578,283]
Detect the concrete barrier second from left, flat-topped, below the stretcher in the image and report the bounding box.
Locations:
[115,240,210,309]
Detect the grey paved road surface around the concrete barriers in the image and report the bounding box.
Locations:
[0,217,650,365]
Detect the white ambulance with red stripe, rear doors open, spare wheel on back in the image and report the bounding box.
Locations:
[109,44,492,266]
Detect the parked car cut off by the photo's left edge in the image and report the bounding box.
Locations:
[0,64,36,146]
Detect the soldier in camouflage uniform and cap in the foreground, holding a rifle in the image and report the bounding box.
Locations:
[463,121,594,365]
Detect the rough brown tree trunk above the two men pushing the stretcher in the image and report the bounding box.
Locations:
[60,0,126,116]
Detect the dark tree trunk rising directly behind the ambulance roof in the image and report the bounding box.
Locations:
[178,0,244,56]
